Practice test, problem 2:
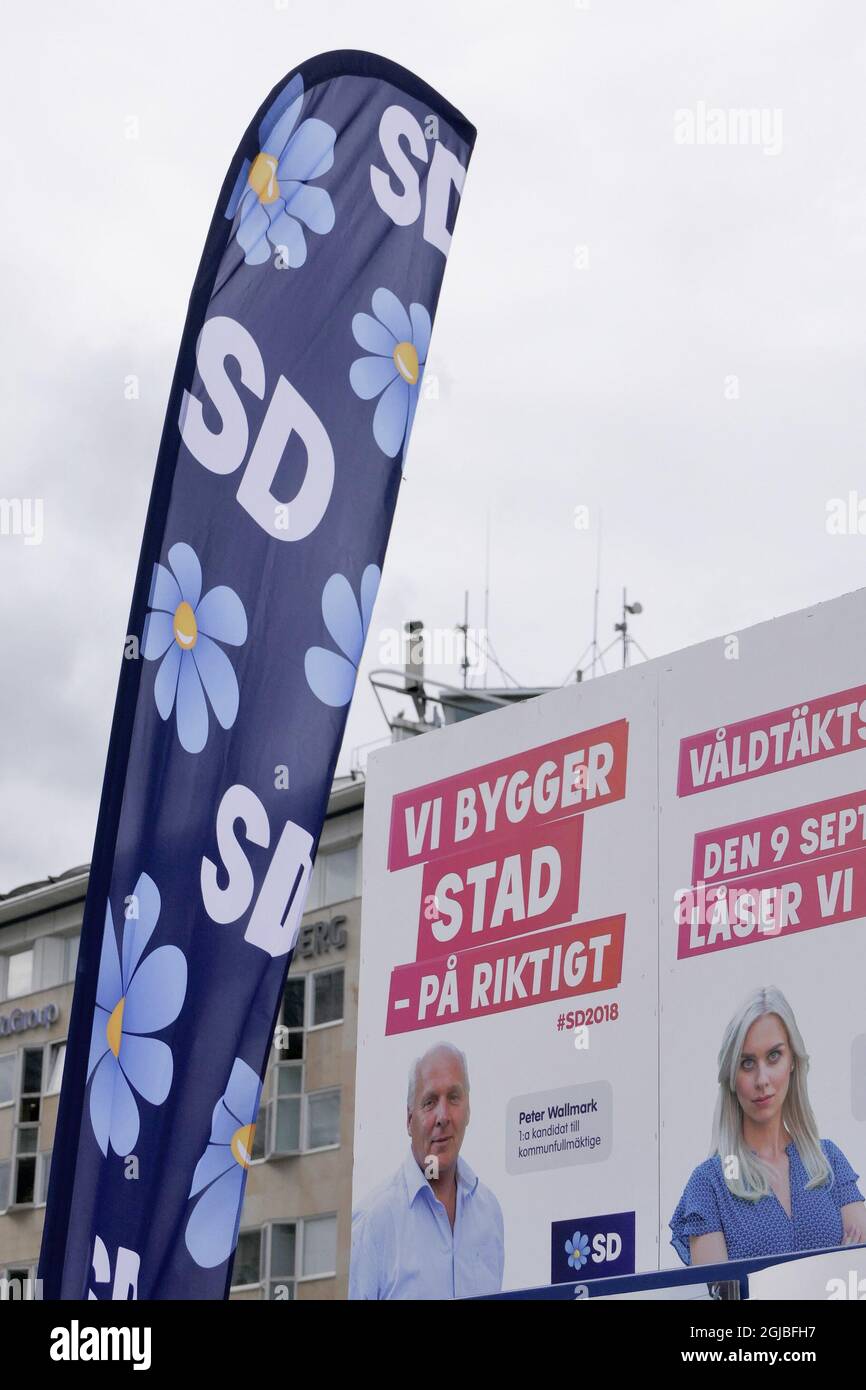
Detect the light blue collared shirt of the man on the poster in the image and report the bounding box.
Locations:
[349,1150,505,1300]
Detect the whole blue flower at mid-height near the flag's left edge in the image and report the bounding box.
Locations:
[142,542,246,753]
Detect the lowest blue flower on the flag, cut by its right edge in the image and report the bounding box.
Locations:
[186,1056,261,1269]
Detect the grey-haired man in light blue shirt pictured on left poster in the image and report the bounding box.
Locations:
[349,1043,505,1300]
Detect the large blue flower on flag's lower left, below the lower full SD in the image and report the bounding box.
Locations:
[88,873,186,1158]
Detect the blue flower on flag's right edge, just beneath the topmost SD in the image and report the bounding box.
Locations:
[349,289,432,459]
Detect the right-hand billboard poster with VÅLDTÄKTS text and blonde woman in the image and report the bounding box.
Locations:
[659,591,866,1259]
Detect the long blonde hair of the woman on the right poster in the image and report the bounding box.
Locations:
[710,984,833,1202]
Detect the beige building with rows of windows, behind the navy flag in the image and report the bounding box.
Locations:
[0,778,364,1300]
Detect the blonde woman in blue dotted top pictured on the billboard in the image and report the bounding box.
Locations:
[670,986,866,1265]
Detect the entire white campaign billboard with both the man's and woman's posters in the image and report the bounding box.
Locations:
[350,591,866,1298]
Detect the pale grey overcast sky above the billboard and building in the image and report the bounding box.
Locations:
[0,0,866,891]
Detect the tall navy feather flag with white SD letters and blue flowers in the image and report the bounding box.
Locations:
[39,51,475,1300]
